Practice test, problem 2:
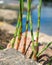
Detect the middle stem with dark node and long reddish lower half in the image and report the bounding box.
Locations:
[22,0,29,54]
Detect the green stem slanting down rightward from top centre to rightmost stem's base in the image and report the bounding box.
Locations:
[28,0,36,60]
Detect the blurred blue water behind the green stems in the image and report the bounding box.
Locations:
[23,0,52,36]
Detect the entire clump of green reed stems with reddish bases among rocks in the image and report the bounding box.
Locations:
[9,0,52,61]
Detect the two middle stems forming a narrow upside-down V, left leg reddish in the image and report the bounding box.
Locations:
[23,0,34,53]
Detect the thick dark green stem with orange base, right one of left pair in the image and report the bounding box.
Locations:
[16,0,23,50]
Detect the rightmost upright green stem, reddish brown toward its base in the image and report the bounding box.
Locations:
[32,0,42,59]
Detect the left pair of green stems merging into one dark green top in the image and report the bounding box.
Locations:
[12,0,23,49]
